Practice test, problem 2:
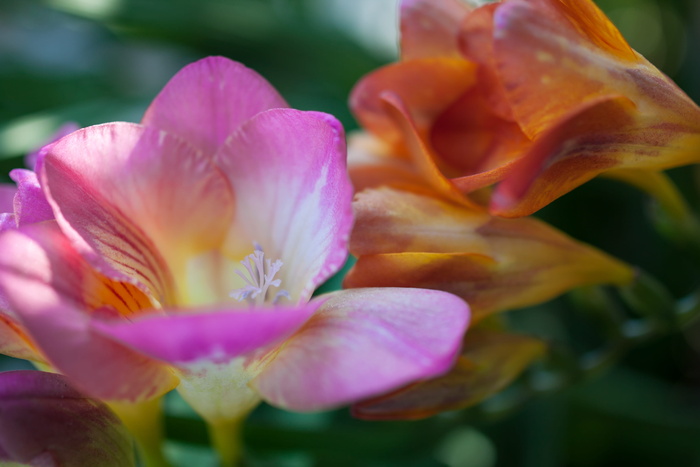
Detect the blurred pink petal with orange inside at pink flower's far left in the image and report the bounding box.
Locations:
[0,222,177,400]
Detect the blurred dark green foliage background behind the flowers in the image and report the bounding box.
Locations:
[0,0,700,467]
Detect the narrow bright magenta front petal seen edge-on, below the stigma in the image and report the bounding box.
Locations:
[92,302,319,365]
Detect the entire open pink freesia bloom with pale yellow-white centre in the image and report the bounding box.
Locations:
[0,57,468,462]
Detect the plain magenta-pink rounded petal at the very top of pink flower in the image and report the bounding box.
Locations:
[141,57,287,156]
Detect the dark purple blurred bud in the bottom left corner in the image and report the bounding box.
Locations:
[0,371,135,467]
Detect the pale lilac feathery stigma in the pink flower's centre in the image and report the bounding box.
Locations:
[230,243,290,305]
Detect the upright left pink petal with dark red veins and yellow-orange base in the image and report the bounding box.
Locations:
[39,123,232,303]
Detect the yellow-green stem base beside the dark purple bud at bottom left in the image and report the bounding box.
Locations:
[109,398,170,467]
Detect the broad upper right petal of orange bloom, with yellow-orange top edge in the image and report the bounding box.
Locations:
[494,0,700,137]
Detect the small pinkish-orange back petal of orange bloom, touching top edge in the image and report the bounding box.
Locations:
[400,0,471,60]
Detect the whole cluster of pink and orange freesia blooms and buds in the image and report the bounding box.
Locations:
[0,0,700,465]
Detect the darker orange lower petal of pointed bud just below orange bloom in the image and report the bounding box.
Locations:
[343,250,633,321]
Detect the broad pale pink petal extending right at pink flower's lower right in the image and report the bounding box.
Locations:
[253,288,469,411]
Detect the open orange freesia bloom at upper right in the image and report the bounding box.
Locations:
[351,0,700,217]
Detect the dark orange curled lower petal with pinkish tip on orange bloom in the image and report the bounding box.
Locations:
[491,96,700,217]
